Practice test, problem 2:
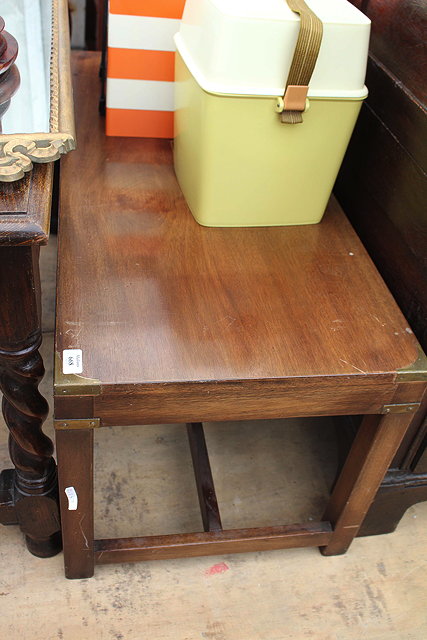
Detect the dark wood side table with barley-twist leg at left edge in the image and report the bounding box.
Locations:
[0,164,61,557]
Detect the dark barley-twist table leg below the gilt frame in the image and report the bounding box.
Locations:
[0,246,62,557]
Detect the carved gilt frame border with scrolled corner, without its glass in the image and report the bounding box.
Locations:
[0,0,76,182]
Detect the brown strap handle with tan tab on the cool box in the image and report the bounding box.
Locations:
[277,0,323,124]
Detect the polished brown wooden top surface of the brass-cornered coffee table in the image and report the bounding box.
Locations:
[57,54,417,385]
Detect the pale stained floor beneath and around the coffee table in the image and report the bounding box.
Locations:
[0,238,427,640]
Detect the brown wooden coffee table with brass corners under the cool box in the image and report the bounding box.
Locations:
[55,53,427,578]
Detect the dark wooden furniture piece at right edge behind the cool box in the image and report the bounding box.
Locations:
[335,0,427,533]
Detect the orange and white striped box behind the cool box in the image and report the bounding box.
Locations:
[106,0,185,138]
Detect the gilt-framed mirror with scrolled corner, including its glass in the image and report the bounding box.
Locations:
[0,0,76,182]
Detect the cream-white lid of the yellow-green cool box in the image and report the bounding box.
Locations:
[175,0,371,99]
